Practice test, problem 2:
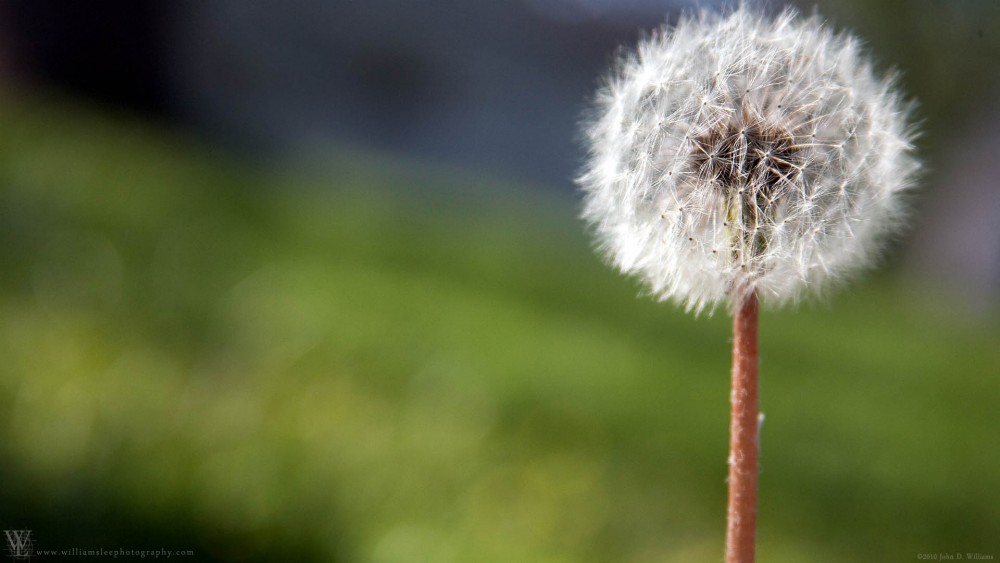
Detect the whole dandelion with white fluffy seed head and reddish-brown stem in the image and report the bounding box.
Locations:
[578,7,919,561]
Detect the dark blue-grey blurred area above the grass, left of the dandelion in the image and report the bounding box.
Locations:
[4,0,662,183]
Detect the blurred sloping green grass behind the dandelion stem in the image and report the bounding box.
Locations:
[0,99,1000,563]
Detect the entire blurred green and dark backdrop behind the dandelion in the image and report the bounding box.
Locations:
[0,0,1000,563]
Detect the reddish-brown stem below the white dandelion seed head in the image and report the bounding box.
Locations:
[726,293,759,563]
